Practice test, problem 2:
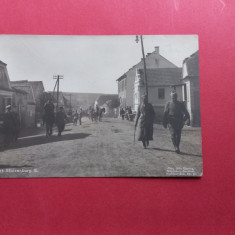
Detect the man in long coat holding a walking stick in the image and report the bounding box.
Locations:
[135,95,155,148]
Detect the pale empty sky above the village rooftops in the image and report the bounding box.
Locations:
[0,35,198,94]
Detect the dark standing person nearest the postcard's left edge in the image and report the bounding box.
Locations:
[3,105,20,148]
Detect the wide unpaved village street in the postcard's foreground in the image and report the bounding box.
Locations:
[0,118,202,178]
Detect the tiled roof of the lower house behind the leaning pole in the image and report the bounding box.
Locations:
[138,68,182,86]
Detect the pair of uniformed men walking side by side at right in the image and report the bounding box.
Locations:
[135,92,190,153]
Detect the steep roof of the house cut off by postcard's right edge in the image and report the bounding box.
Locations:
[183,51,199,76]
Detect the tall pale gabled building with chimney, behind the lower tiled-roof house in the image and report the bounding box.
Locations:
[116,47,177,108]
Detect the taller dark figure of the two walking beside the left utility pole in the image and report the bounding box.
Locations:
[43,98,55,137]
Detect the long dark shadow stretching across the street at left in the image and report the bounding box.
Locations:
[0,133,91,151]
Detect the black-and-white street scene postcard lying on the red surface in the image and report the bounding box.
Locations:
[0,35,203,178]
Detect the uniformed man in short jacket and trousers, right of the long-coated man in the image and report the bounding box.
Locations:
[163,92,190,153]
